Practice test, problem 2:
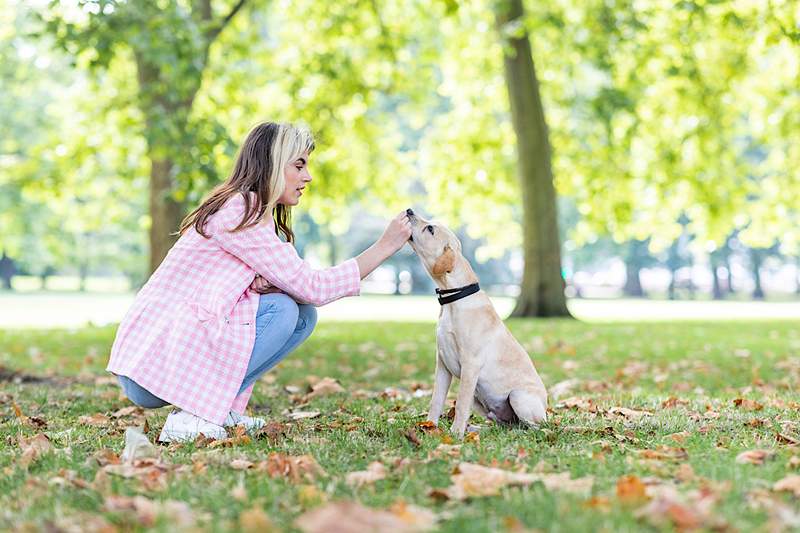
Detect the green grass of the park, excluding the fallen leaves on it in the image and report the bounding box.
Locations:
[0,320,800,532]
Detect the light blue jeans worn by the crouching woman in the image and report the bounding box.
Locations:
[118,293,317,409]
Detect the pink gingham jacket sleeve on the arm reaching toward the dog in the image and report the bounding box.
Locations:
[209,195,361,306]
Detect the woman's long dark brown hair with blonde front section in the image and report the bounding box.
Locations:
[180,122,314,242]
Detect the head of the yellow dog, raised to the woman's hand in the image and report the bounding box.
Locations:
[406,209,461,279]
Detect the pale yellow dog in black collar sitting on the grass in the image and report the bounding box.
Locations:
[406,209,547,438]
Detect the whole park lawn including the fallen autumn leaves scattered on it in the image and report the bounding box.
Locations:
[0,320,800,532]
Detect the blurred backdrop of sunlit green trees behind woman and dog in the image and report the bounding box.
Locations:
[0,0,800,315]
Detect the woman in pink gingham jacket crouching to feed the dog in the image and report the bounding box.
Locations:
[106,122,411,442]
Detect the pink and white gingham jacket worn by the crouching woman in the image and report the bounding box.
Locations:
[106,193,361,425]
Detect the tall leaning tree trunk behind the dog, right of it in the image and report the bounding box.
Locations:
[495,0,571,317]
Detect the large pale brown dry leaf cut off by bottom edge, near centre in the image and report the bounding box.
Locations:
[295,501,435,533]
